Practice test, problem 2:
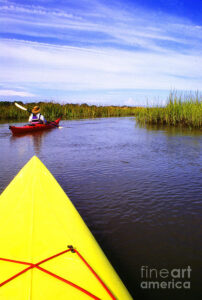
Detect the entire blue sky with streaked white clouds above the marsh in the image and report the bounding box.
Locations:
[0,0,202,105]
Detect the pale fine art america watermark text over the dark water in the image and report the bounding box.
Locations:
[140,266,192,289]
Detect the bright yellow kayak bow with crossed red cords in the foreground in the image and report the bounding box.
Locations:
[0,156,132,300]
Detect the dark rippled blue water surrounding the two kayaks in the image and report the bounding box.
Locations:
[0,118,202,300]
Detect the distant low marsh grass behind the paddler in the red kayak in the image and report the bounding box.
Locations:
[0,102,142,121]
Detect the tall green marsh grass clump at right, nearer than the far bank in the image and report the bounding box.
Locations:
[137,93,202,128]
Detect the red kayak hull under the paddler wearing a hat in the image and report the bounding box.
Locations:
[9,118,61,134]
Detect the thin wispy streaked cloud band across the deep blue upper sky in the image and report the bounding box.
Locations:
[0,1,202,51]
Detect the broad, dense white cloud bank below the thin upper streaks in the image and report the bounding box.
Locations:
[0,40,202,90]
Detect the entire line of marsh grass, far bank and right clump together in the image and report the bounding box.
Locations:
[0,92,202,128]
